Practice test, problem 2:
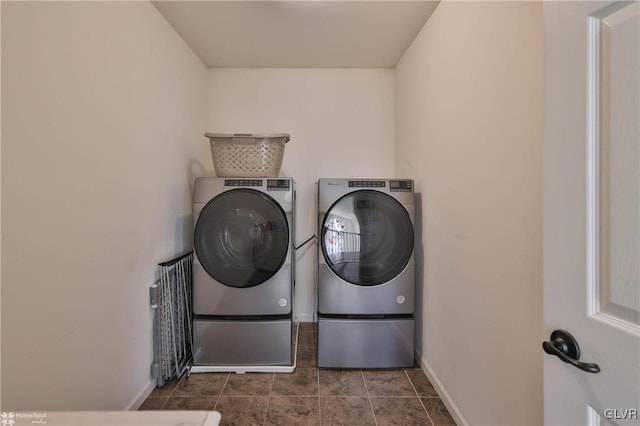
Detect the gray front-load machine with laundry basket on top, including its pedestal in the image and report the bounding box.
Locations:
[193,177,295,365]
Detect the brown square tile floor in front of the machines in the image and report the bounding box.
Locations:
[140,323,455,426]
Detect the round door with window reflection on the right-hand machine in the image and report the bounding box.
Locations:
[320,190,413,286]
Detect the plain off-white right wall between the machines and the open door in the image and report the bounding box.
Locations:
[395,2,543,425]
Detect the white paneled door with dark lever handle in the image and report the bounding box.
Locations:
[541,1,640,425]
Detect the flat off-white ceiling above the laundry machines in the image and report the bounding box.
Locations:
[153,0,439,68]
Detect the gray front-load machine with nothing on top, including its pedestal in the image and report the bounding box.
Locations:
[317,179,415,368]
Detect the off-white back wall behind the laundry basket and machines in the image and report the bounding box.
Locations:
[207,69,394,321]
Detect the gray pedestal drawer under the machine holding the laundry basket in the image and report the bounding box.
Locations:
[193,318,293,366]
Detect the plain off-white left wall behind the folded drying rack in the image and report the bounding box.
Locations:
[2,2,208,411]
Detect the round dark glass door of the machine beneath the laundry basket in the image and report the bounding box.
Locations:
[194,188,289,288]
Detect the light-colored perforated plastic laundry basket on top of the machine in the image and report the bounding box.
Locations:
[205,133,290,177]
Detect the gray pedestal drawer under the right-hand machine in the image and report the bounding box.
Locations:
[318,316,414,369]
